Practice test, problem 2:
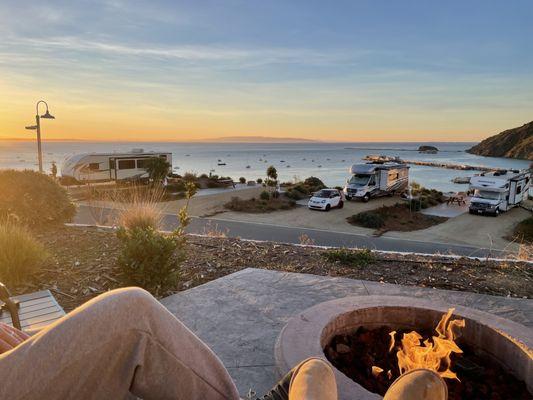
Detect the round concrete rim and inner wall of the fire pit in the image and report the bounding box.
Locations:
[275,296,533,400]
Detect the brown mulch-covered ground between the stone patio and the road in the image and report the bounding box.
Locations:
[12,227,533,311]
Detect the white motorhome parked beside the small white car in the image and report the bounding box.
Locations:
[344,162,409,202]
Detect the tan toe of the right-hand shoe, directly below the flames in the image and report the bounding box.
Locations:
[383,369,448,400]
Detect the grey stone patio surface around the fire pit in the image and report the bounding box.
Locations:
[161,268,533,396]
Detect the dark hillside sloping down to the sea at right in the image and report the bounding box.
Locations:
[467,121,533,161]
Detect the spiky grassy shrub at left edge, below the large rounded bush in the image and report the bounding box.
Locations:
[0,222,48,284]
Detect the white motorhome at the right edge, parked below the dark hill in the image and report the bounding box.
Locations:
[469,170,531,216]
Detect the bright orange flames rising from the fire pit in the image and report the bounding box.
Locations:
[391,308,465,380]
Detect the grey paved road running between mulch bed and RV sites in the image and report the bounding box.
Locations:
[75,206,504,257]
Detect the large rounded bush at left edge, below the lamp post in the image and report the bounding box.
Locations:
[0,170,76,226]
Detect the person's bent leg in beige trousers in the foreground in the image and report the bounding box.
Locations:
[0,288,239,400]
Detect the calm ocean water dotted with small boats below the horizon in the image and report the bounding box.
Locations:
[0,141,529,191]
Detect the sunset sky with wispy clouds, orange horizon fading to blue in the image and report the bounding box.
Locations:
[0,0,533,141]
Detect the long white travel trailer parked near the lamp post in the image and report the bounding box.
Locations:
[61,149,172,182]
